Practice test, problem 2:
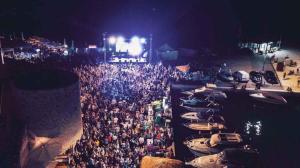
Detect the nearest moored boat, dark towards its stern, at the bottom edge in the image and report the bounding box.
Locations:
[185,148,263,168]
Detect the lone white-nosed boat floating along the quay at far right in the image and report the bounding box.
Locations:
[250,92,287,104]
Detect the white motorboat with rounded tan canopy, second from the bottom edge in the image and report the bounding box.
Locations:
[183,133,243,156]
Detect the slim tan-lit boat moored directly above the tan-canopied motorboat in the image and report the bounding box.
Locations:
[183,121,226,131]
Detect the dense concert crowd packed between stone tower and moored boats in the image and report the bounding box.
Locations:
[69,64,181,168]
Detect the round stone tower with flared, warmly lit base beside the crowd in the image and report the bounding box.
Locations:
[1,71,83,167]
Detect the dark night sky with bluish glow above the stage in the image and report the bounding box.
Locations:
[0,0,300,48]
